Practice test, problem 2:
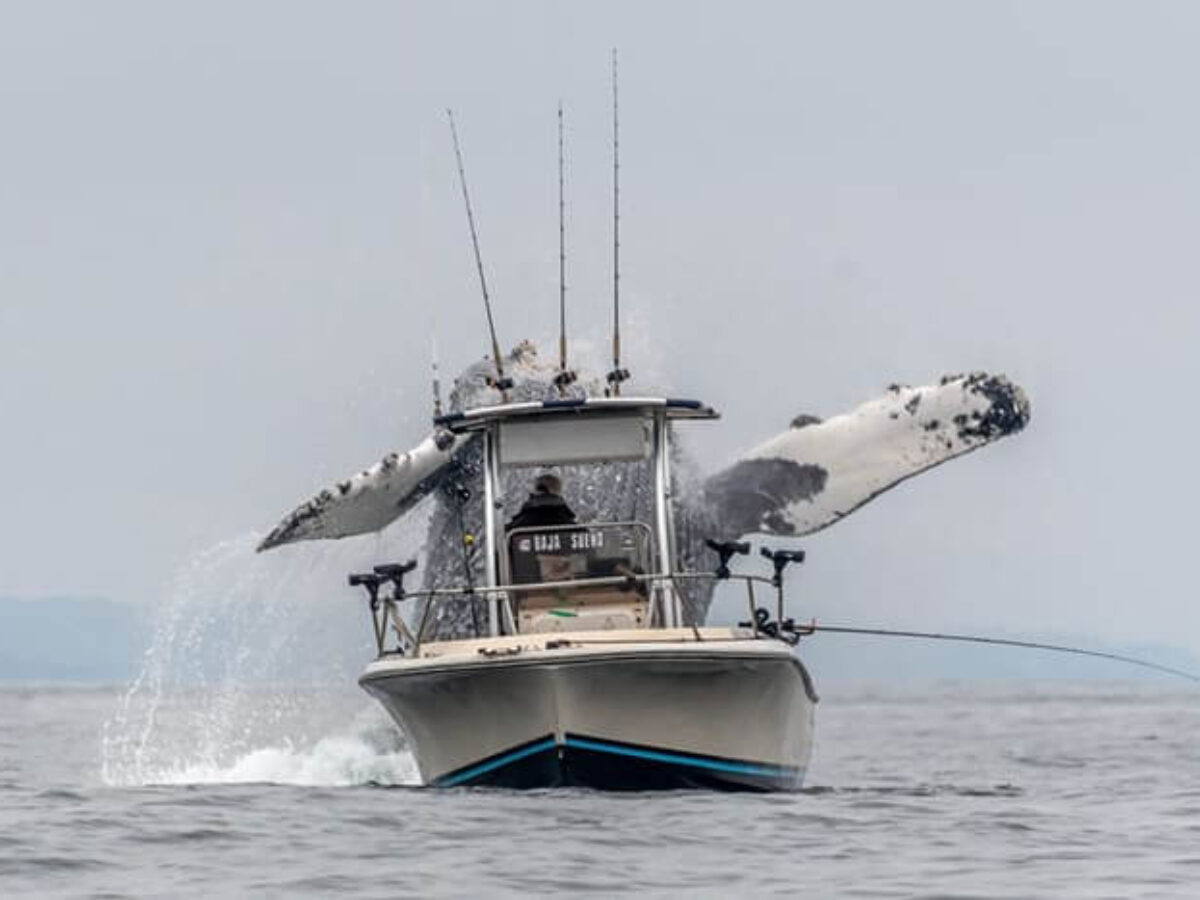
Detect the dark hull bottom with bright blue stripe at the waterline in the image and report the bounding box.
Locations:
[433,734,804,791]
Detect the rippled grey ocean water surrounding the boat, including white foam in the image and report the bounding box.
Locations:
[0,680,1200,898]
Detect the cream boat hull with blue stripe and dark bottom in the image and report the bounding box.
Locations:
[360,641,816,791]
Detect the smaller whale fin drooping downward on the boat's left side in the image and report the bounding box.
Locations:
[258,431,470,552]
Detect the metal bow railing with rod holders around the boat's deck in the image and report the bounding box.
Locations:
[350,566,811,656]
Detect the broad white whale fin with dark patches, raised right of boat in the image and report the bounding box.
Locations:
[704,372,1030,535]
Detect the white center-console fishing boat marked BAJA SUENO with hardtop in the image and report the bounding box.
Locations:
[354,397,817,790]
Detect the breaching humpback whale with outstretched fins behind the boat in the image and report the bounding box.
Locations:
[258,341,1030,638]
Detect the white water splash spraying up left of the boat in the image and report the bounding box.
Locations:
[101,514,427,785]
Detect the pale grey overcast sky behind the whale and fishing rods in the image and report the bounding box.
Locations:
[0,0,1200,649]
